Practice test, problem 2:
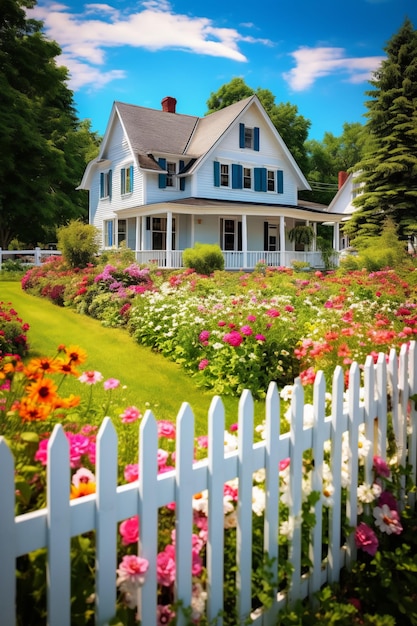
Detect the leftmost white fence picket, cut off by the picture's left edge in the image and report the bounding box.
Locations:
[0,437,16,626]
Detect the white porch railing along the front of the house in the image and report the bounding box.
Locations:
[135,250,339,270]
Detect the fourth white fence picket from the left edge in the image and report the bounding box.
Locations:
[138,411,158,626]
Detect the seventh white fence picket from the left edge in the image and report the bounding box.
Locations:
[236,389,253,624]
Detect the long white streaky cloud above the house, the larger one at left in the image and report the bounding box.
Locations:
[29,0,271,89]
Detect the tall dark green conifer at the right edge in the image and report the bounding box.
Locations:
[345,19,417,241]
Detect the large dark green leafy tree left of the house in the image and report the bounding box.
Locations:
[0,0,98,248]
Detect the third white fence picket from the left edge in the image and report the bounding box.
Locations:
[96,417,117,626]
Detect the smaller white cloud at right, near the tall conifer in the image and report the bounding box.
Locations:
[283,47,385,91]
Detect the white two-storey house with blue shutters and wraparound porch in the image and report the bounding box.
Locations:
[79,96,345,269]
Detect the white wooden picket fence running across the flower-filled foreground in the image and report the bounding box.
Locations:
[0,342,417,626]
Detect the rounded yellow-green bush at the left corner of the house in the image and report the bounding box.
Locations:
[57,220,99,268]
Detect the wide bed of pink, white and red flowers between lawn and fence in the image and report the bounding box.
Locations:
[22,260,417,398]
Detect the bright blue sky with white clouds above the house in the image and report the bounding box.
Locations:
[30,0,417,141]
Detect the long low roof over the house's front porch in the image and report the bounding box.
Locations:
[111,198,345,223]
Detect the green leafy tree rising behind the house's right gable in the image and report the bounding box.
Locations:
[206,77,311,171]
